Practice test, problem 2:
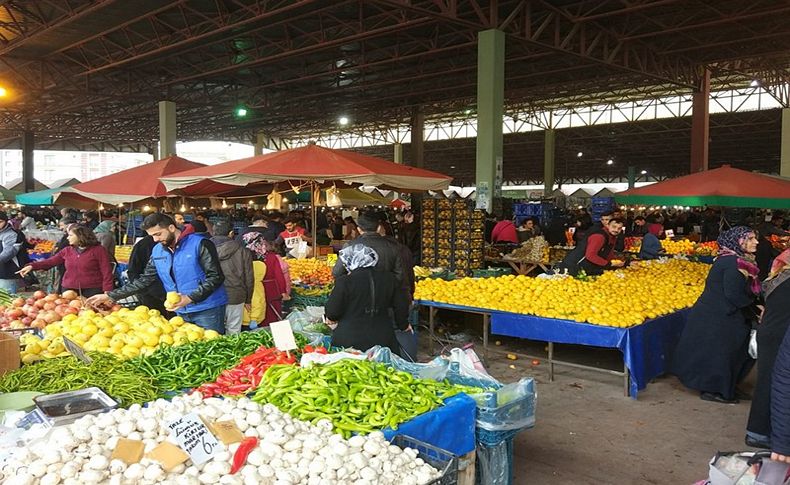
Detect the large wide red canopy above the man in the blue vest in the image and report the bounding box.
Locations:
[160,145,452,196]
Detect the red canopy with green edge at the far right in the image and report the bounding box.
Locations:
[615,165,790,209]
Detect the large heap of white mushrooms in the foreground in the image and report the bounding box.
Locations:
[0,393,440,485]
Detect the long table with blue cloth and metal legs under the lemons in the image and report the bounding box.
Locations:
[417,301,688,399]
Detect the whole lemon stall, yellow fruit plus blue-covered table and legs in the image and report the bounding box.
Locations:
[415,260,709,399]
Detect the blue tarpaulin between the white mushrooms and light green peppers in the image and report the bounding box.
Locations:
[382,394,477,456]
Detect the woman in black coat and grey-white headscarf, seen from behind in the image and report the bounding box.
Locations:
[325,244,409,354]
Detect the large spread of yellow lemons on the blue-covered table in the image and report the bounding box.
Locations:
[415,259,710,327]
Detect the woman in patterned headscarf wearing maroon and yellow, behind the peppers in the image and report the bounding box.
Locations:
[243,232,290,328]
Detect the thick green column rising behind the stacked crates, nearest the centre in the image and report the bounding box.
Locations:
[475,29,505,211]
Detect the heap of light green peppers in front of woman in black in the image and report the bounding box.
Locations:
[252,359,484,437]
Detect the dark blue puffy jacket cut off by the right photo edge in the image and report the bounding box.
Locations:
[771,322,790,456]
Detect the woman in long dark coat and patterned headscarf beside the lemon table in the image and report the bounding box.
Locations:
[672,226,760,404]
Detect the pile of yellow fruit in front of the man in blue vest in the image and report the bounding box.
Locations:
[20,306,219,363]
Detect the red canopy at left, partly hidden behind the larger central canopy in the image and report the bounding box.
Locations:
[56,156,205,205]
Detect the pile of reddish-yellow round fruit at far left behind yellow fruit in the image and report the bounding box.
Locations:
[0,290,120,329]
